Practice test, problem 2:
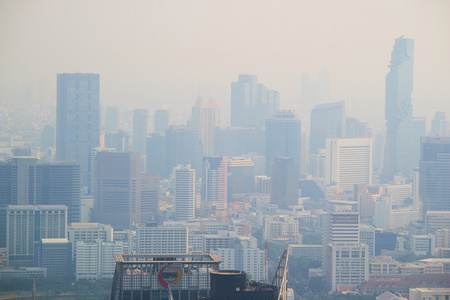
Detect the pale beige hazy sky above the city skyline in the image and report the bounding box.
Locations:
[0,0,450,125]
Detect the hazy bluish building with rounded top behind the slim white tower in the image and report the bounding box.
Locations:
[161,126,203,178]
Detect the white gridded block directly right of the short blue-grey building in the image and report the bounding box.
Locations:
[75,241,123,281]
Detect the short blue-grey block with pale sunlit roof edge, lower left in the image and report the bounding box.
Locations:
[34,238,72,279]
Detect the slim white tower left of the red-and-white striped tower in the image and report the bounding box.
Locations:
[173,165,195,221]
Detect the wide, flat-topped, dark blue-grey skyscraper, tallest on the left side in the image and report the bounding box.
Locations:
[56,73,100,186]
